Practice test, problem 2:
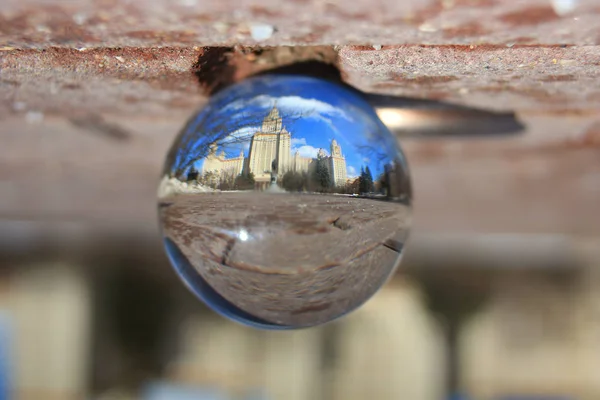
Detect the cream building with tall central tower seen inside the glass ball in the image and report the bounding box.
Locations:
[200,107,348,187]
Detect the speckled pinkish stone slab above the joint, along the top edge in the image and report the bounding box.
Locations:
[0,0,600,47]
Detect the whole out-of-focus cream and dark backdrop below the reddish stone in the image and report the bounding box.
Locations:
[0,225,600,400]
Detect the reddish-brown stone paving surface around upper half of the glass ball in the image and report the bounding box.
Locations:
[0,0,600,256]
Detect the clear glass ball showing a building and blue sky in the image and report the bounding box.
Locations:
[159,75,410,329]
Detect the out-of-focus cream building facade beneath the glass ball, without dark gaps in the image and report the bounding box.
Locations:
[0,256,600,400]
